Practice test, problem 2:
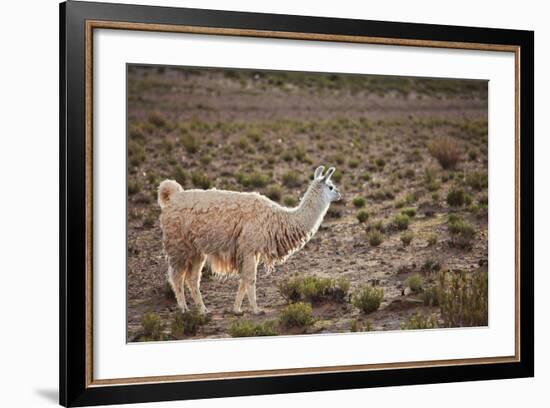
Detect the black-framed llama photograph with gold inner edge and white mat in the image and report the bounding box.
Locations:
[60,1,534,406]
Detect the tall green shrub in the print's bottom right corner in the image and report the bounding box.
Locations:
[437,271,489,327]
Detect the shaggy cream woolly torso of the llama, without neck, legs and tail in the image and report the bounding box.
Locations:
[161,183,281,272]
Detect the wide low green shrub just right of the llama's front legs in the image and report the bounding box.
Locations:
[277,276,349,303]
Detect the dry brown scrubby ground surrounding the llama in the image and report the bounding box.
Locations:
[127,67,488,341]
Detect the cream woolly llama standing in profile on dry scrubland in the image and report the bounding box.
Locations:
[158,166,341,315]
